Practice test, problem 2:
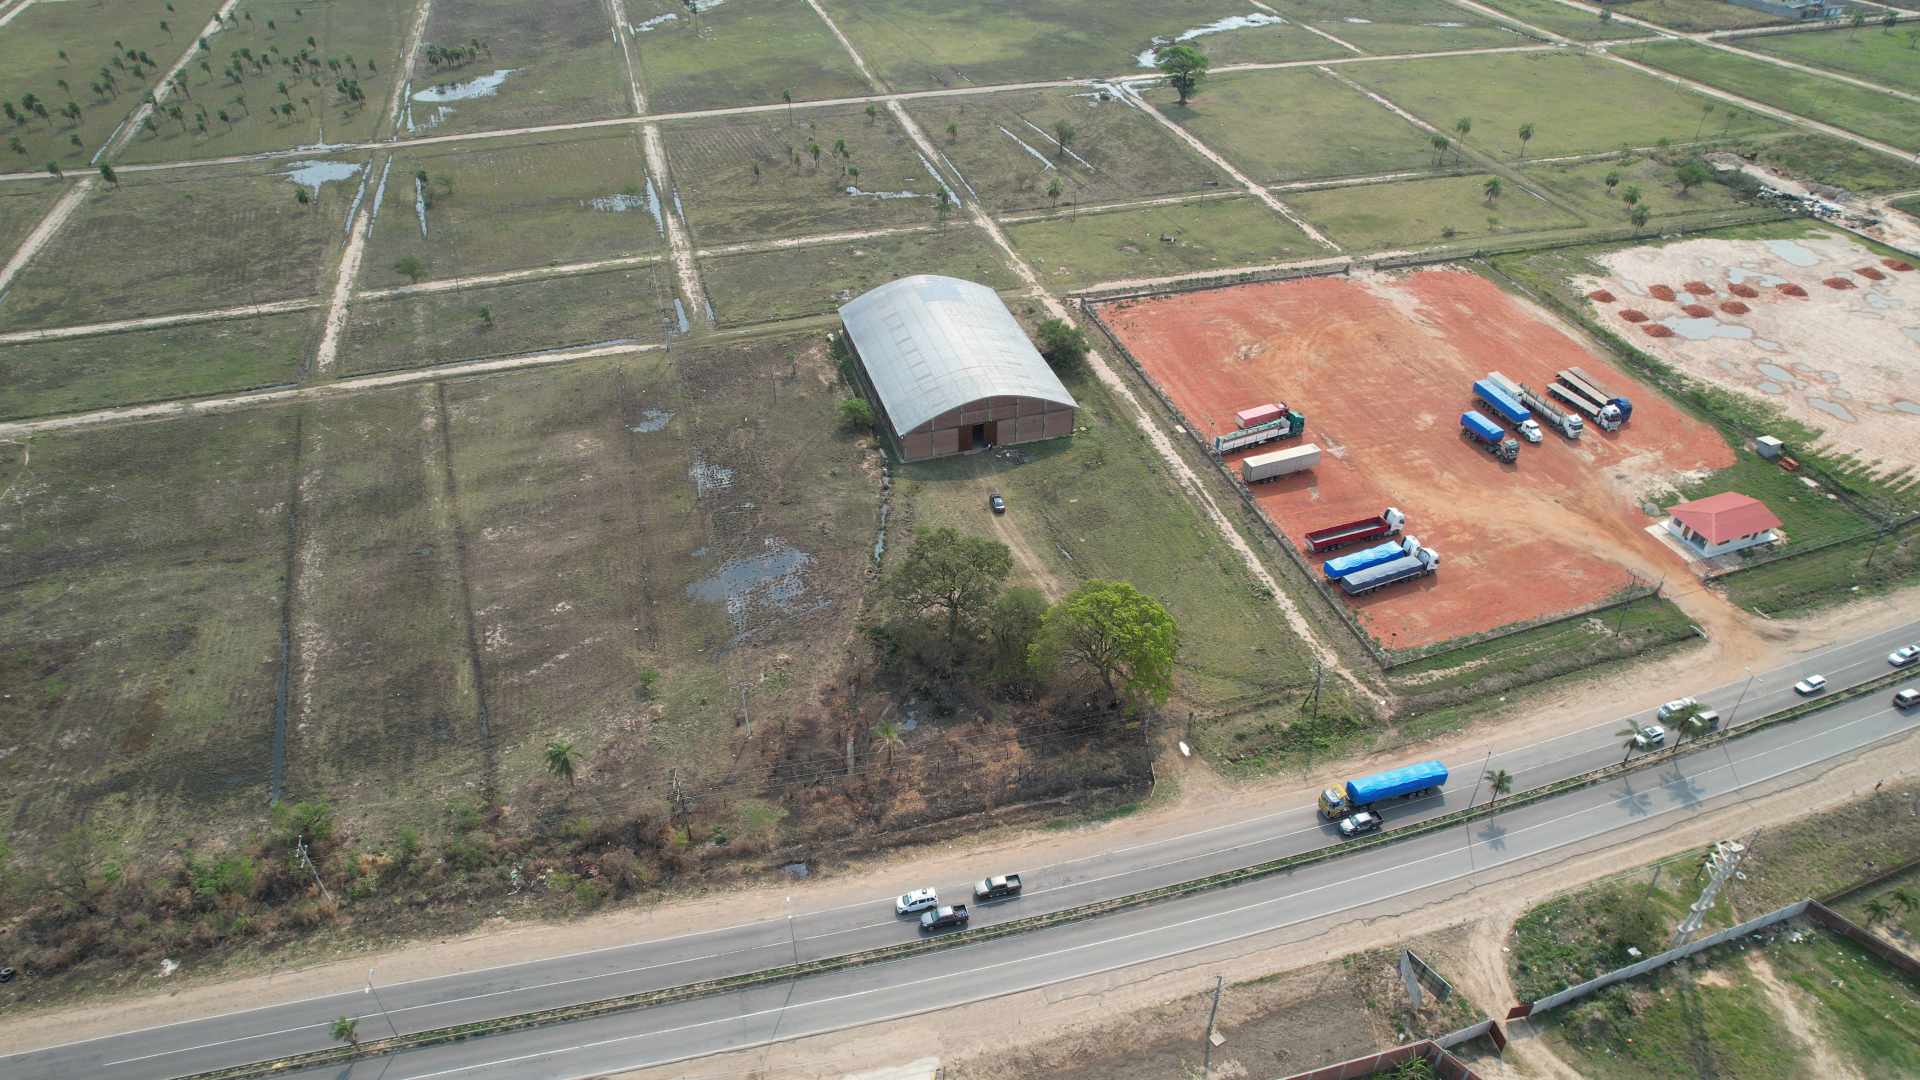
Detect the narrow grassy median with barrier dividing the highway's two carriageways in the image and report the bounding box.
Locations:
[177,661,1908,1080]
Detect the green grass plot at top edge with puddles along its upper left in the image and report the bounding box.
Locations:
[626,0,868,113]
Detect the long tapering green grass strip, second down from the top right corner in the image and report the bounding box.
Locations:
[1617,42,1920,148]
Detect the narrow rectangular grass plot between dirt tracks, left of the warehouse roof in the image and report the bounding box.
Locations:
[340,267,675,373]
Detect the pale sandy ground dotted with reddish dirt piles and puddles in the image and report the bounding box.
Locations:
[1578,236,1920,467]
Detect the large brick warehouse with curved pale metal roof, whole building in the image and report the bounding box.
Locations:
[841,275,1077,461]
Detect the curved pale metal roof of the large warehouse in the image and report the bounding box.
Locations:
[841,273,1077,434]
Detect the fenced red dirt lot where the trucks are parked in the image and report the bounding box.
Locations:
[1100,269,1734,648]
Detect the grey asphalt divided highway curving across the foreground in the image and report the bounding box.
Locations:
[0,623,1920,1080]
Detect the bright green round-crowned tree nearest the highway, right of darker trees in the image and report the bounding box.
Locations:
[1029,578,1181,705]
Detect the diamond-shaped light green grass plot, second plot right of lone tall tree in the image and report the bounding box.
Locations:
[1346,46,1780,160]
